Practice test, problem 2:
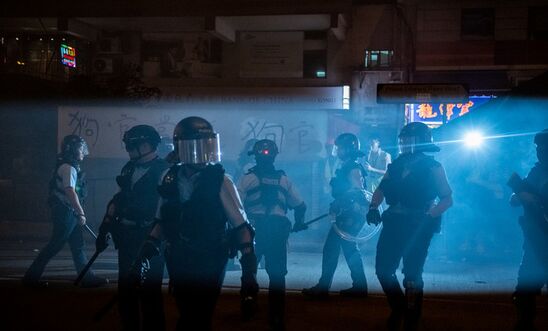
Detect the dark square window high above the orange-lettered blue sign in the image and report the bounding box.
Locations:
[460,8,495,39]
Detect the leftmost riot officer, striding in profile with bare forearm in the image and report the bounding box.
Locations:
[23,135,108,287]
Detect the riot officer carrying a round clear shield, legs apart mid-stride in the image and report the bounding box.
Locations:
[303,133,368,298]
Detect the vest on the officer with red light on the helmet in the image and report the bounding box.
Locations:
[244,166,288,215]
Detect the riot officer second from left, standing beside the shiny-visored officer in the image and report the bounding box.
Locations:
[96,125,169,330]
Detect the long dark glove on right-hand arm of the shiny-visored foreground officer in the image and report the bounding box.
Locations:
[240,252,259,320]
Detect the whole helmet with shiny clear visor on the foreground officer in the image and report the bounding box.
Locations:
[173,116,221,164]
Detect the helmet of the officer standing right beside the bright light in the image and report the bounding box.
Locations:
[398,122,440,153]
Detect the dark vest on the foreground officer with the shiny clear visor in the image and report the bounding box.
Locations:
[159,164,228,250]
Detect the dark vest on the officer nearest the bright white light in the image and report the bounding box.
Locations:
[381,153,440,211]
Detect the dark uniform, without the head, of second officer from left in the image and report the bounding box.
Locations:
[111,157,168,330]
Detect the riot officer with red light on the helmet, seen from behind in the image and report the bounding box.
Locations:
[238,139,306,330]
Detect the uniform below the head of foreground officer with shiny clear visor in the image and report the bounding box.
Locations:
[158,165,247,330]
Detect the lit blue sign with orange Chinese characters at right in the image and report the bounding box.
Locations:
[405,96,494,127]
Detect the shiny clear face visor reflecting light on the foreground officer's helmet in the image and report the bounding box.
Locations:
[177,134,221,164]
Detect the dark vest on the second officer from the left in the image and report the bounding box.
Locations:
[115,158,168,225]
